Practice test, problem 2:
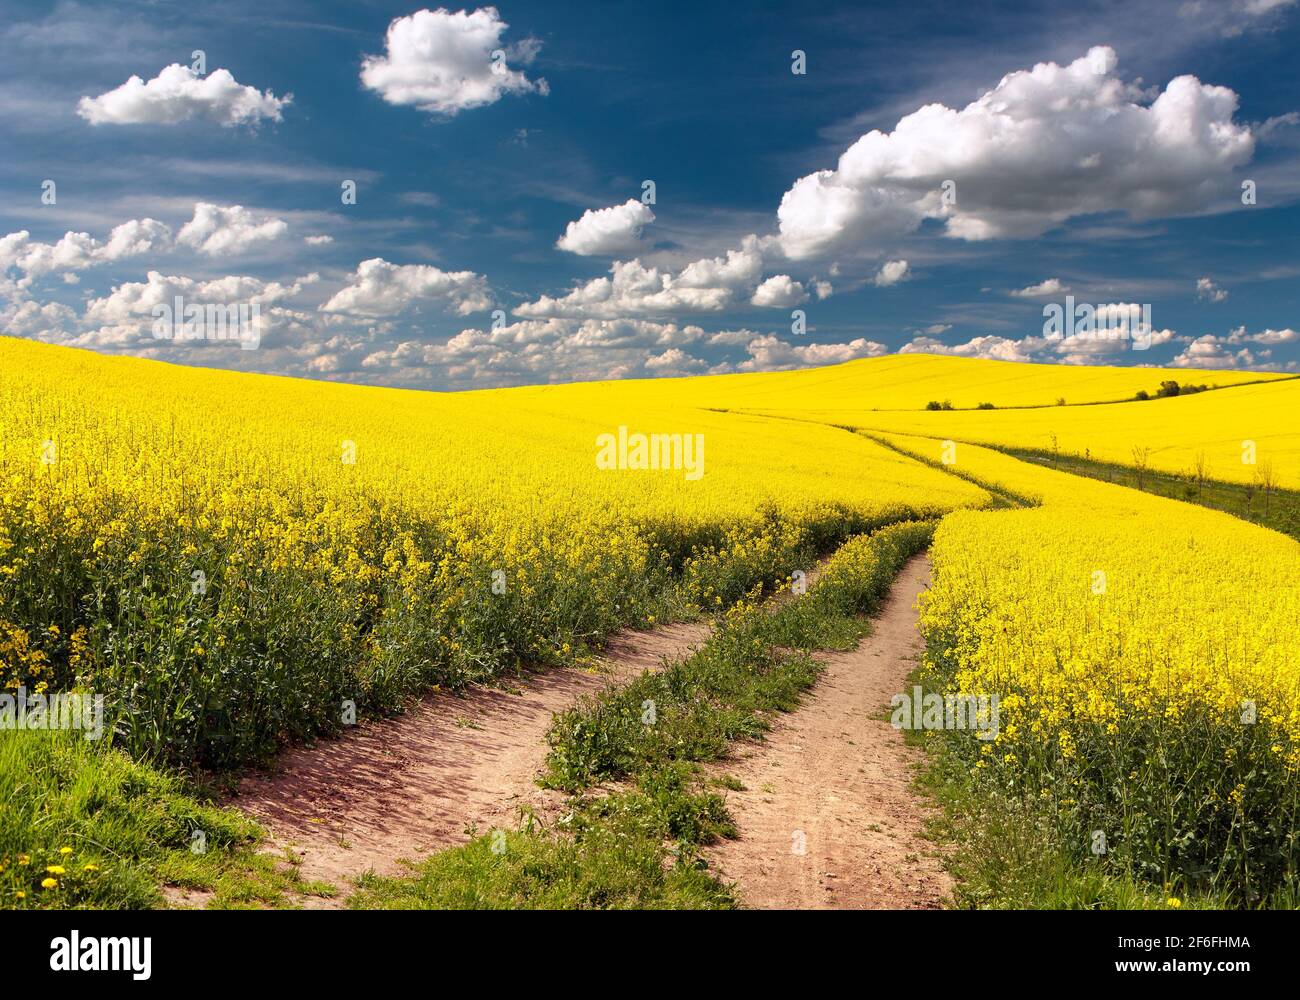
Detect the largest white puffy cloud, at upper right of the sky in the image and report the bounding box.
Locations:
[777,47,1255,259]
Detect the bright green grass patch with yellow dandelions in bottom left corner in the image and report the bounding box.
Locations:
[0,730,326,909]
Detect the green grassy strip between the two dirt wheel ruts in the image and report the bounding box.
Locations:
[350,523,933,909]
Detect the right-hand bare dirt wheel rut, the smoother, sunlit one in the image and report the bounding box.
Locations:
[709,555,952,909]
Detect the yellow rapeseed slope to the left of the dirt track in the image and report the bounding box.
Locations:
[0,338,985,763]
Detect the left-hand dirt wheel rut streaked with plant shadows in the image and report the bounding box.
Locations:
[231,624,709,906]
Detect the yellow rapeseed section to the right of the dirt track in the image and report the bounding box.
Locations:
[883,436,1300,902]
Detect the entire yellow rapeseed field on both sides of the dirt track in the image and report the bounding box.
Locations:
[0,338,1300,905]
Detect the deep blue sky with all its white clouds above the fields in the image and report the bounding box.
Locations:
[0,0,1300,389]
